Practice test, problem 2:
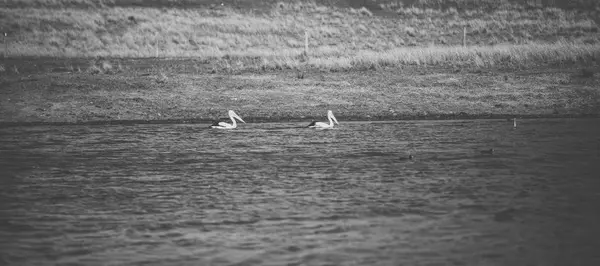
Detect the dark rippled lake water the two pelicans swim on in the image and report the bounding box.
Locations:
[0,119,600,265]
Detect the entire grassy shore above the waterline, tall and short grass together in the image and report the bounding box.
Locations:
[0,0,600,122]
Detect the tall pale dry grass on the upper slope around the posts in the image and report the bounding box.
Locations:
[0,0,600,70]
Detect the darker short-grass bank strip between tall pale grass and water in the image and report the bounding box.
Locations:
[0,60,600,122]
